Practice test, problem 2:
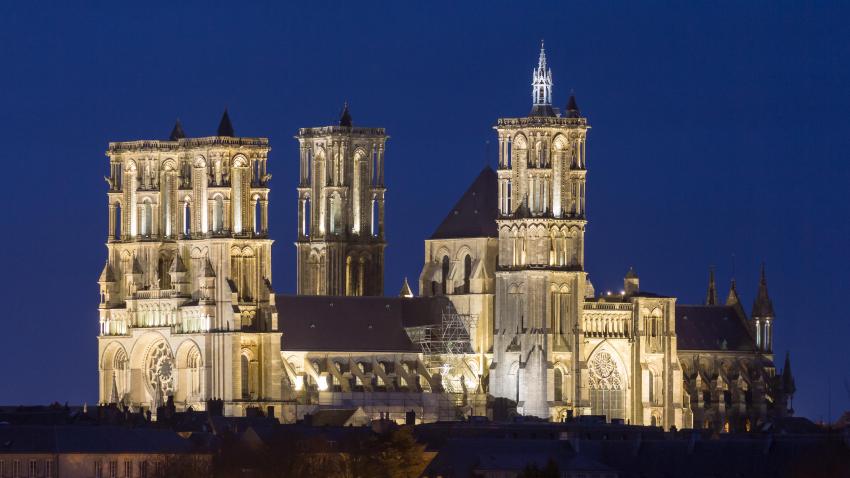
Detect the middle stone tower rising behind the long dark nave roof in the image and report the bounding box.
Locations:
[295,104,387,295]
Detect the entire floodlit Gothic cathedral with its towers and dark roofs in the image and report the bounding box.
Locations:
[98,45,794,431]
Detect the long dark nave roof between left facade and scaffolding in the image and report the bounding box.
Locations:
[275,295,449,352]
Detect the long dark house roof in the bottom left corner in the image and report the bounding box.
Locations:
[0,425,203,454]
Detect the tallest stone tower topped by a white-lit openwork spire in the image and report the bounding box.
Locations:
[490,44,590,417]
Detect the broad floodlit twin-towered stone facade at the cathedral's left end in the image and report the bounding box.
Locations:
[98,111,280,415]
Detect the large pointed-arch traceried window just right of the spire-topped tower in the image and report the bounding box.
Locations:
[588,350,626,420]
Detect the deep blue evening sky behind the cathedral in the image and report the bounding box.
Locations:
[0,2,850,420]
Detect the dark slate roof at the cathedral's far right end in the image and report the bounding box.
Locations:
[676,305,755,352]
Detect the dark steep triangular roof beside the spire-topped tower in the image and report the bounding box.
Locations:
[430,166,499,239]
